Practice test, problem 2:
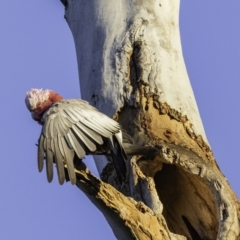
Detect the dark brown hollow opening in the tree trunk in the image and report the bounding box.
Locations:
[154,164,218,240]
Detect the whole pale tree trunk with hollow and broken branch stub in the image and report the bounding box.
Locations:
[62,0,240,240]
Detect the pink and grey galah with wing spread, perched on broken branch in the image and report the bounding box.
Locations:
[25,89,156,184]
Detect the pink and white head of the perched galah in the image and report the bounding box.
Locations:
[25,88,63,124]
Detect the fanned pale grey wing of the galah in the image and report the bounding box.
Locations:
[38,99,120,184]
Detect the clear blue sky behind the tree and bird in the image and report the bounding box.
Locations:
[0,0,240,240]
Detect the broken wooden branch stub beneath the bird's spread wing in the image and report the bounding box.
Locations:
[76,167,186,240]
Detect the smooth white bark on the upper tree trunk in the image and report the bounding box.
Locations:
[65,0,207,142]
